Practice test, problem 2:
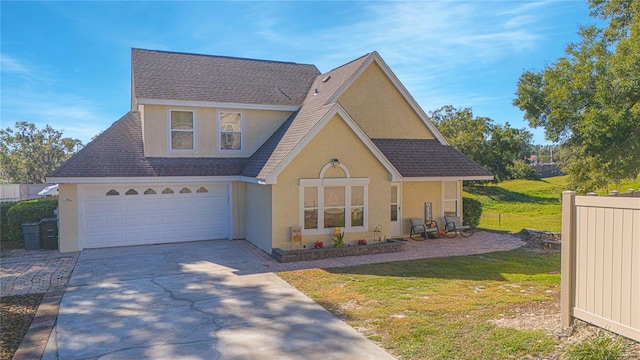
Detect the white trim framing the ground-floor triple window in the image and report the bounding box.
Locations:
[298,178,369,235]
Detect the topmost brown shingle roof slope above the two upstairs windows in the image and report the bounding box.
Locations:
[131,49,320,106]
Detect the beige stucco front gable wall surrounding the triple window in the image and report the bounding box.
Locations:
[270,115,391,250]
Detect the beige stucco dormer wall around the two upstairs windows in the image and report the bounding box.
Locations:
[143,105,291,157]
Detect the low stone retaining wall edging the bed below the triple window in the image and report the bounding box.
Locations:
[271,240,404,263]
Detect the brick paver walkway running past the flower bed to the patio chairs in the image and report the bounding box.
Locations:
[238,231,525,272]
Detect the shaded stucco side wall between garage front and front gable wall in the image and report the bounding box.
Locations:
[244,183,273,254]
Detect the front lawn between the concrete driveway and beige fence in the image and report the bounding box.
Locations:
[279,249,560,359]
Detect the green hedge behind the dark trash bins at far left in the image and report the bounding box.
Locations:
[2,197,58,241]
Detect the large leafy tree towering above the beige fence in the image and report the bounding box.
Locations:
[513,0,640,192]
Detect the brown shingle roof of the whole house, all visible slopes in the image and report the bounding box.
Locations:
[49,49,492,179]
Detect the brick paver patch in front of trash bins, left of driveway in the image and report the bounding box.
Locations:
[0,249,80,296]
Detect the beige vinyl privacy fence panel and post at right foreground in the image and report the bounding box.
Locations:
[561,191,640,341]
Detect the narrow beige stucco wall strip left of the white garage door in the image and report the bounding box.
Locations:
[58,184,80,252]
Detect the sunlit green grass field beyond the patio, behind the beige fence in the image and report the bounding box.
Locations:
[464,176,640,233]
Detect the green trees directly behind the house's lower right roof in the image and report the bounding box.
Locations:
[429,105,538,181]
